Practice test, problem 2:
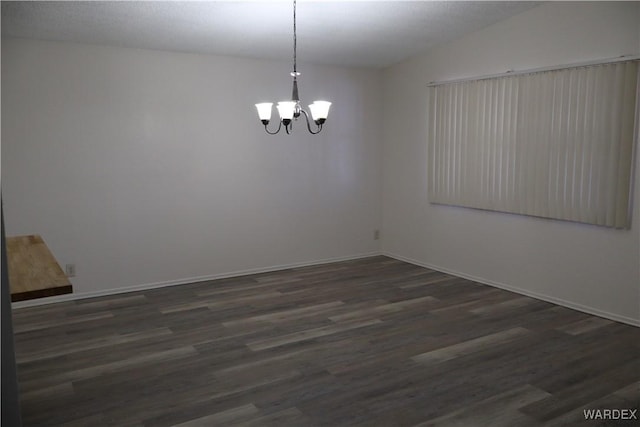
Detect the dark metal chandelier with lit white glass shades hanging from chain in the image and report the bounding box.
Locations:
[256,0,331,135]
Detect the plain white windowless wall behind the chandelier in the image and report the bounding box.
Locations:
[2,39,381,300]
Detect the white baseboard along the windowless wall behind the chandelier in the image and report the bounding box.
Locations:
[11,251,381,309]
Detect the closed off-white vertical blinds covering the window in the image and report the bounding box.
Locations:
[428,61,638,228]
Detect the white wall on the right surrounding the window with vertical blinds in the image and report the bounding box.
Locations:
[382,2,640,323]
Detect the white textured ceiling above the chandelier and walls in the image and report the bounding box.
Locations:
[2,0,539,68]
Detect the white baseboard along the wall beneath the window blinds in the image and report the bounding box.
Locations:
[382,251,640,326]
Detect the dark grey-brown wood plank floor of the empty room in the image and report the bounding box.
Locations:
[14,257,640,427]
